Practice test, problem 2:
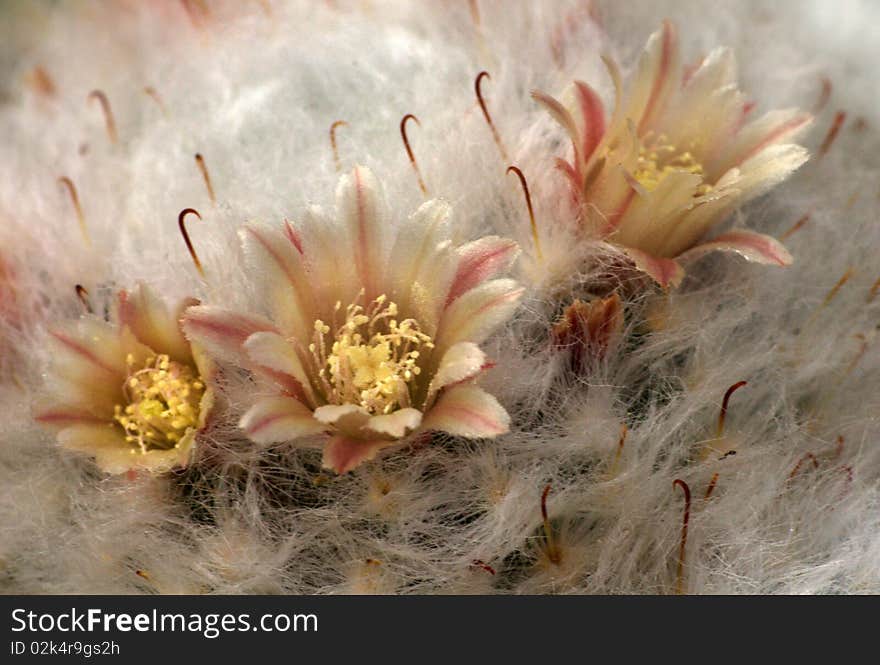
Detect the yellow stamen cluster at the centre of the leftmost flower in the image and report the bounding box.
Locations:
[113,354,205,453]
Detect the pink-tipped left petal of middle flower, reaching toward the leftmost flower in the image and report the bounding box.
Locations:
[183,305,277,367]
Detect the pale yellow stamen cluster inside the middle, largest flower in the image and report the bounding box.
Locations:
[309,292,434,414]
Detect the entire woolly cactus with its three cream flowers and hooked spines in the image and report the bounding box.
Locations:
[0,0,880,593]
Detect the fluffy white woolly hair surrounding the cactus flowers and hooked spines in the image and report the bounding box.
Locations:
[0,0,880,594]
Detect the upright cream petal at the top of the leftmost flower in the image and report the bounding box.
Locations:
[117,283,198,363]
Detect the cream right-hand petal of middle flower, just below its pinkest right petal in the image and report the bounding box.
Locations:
[436,279,524,352]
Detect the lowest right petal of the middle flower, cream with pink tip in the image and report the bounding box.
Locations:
[422,385,510,439]
